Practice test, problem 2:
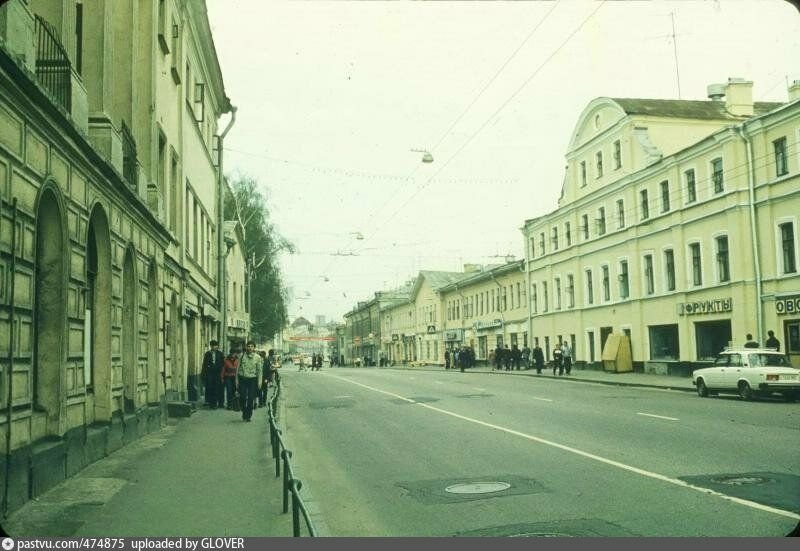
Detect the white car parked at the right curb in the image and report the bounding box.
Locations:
[692,348,800,400]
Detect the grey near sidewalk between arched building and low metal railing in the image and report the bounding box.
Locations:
[2,398,292,537]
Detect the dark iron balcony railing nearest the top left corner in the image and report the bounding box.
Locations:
[36,15,72,113]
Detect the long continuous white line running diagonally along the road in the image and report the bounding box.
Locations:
[328,375,800,520]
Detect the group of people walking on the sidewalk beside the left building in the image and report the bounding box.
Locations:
[201,340,280,422]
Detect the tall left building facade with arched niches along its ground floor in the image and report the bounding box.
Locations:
[0,0,236,510]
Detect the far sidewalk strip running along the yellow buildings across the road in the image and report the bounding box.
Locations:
[374,365,695,392]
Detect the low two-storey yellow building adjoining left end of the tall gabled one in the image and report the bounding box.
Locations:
[440,260,528,361]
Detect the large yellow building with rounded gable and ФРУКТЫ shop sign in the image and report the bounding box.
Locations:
[523,79,800,373]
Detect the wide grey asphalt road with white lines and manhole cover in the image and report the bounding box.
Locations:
[282,369,800,536]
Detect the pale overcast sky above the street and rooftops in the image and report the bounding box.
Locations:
[207,0,800,321]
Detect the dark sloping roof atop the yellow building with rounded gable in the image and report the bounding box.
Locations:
[609,98,783,120]
